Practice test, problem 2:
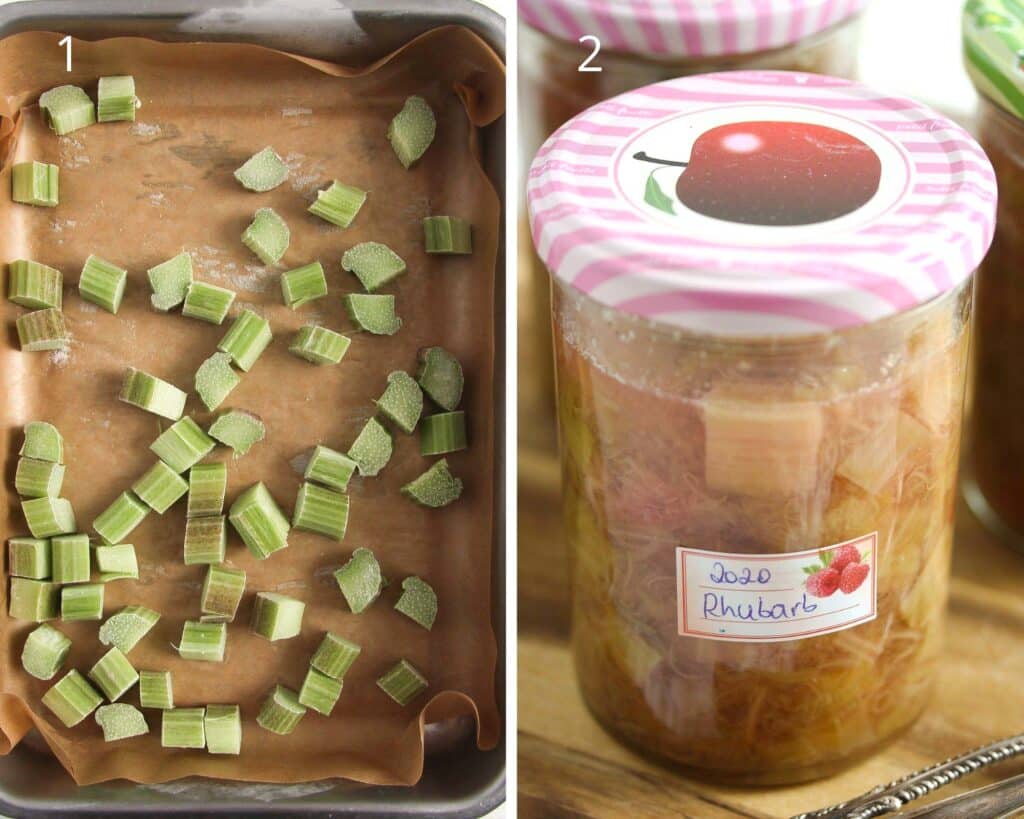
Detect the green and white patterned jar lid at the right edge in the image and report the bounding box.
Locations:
[964,0,1024,119]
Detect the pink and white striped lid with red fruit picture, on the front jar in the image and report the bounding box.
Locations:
[526,72,996,337]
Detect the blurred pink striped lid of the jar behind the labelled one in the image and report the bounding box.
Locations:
[519,0,867,59]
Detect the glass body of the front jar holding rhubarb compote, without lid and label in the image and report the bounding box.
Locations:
[554,285,971,783]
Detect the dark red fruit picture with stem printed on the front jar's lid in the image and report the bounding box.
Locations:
[633,122,882,226]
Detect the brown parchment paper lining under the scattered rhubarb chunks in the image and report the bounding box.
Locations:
[0,27,504,784]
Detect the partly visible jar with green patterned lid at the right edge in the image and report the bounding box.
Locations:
[965,2,1024,548]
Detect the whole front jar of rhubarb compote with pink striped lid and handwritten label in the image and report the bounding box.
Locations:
[529,72,994,784]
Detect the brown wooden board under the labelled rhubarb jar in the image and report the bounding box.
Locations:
[518,452,1024,819]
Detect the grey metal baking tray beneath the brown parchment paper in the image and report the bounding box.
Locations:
[0,0,506,819]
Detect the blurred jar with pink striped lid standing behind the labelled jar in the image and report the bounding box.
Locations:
[518,0,864,448]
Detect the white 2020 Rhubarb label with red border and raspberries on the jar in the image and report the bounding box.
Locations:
[676,532,879,643]
